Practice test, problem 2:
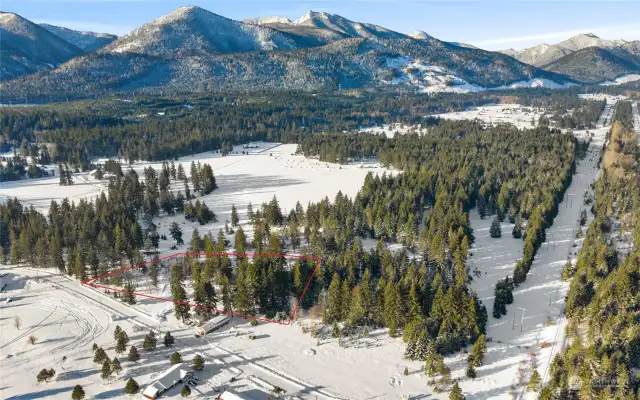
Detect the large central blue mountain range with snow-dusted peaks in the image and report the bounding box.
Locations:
[0,6,568,98]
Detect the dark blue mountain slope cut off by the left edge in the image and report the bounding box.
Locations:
[0,12,83,81]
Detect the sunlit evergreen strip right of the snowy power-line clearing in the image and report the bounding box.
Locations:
[540,109,640,400]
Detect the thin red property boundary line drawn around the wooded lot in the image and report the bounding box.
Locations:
[81,252,321,325]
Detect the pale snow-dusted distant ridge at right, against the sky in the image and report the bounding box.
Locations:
[500,33,627,67]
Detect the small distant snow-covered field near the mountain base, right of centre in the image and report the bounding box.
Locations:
[434,104,543,129]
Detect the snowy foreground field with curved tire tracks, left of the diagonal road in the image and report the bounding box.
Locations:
[0,267,334,400]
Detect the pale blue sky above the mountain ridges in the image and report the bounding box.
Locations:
[2,0,640,50]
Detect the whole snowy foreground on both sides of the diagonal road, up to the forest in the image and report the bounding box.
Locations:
[0,267,428,400]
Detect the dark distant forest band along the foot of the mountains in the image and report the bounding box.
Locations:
[0,92,588,169]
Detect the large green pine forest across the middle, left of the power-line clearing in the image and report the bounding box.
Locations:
[0,94,576,360]
